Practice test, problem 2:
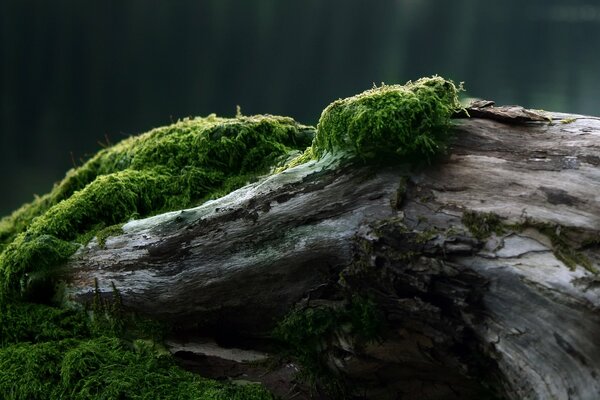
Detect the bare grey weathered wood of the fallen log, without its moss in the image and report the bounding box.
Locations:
[66,107,600,399]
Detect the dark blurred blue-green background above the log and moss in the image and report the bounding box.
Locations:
[0,0,600,215]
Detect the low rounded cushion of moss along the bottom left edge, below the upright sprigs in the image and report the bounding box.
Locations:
[0,337,272,400]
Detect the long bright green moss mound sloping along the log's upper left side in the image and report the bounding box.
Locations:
[0,115,313,295]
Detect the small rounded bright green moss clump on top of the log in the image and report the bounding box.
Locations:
[313,76,461,161]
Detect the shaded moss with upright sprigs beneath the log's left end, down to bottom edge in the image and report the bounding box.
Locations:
[0,292,272,400]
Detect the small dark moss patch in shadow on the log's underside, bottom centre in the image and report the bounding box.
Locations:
[273,296,383,398]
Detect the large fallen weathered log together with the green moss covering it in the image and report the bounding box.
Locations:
[0,77,600,399]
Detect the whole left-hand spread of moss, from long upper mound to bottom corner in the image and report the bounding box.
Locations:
[0,115,314,399]
